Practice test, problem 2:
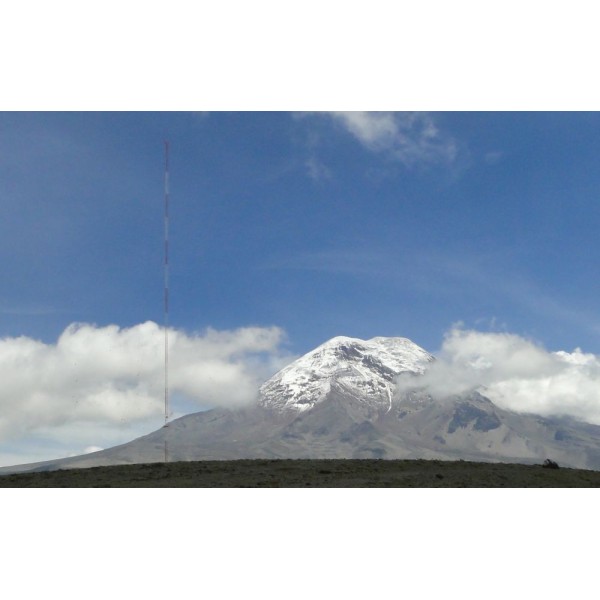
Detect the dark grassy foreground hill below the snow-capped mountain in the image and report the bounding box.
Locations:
[0,459,600,488]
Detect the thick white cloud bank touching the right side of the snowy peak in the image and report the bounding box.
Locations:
[398,328,600,424]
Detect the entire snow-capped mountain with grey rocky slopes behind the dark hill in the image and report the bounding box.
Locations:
[0,337,600,473]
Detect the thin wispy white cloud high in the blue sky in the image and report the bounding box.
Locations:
[326,111,457,167]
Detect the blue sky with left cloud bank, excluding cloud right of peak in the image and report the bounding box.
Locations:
[5,111,600,464]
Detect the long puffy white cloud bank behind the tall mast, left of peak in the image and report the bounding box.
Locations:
[0,322,286,462]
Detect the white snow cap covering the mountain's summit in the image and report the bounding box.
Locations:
[259,336,433,412]
